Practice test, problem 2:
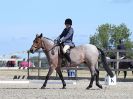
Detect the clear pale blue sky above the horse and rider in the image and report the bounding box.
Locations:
[0,0,133,55]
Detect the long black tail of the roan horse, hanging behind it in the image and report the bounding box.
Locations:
[97,48,114,77]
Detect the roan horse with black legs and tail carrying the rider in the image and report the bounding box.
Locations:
[29,33,114,89]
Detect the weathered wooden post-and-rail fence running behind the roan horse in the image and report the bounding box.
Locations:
[27,50,133,77]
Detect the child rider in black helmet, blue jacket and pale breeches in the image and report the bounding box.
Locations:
[55,18,75,64]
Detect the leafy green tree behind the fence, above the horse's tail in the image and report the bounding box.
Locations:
[90,23,133,49]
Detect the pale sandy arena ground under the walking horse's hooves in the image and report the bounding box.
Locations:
[0,80,133,99]
